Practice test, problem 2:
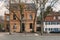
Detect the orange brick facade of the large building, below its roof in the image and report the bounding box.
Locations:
[4,4,36,32]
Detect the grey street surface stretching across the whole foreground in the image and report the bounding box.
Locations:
[0,33,60,40]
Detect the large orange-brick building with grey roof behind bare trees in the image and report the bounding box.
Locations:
[4,3,36,32]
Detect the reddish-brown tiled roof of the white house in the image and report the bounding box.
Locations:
[44,12,60,22]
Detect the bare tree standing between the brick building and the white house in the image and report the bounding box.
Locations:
[33,0,58,35]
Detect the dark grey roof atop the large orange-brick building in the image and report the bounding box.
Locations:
[10,3,36,10]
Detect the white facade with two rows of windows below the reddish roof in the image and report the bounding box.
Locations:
[44,22,60,32]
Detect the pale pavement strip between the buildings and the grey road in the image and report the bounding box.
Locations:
[0,32,60,36]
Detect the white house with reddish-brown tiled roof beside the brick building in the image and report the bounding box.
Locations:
[44,12,60,32]
